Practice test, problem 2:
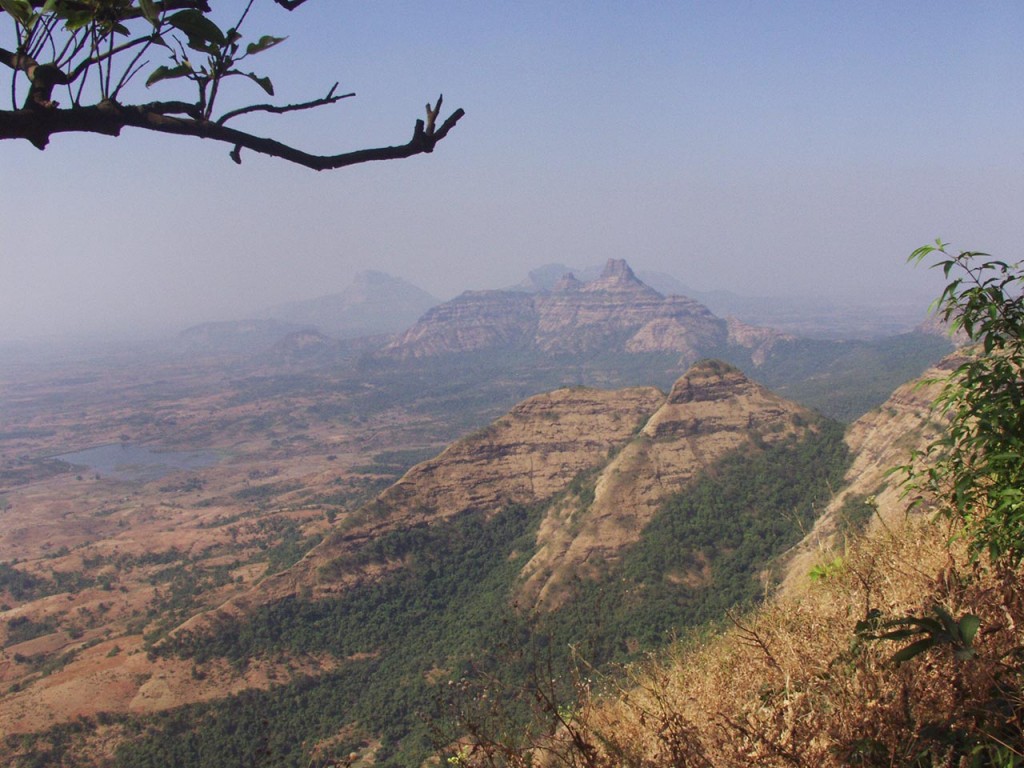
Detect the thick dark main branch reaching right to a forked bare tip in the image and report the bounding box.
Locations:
[0,98,465,171]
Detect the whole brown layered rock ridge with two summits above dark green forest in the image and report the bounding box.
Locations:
[195,360,815,618]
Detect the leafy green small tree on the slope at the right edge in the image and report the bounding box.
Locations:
[910,241,1024,567]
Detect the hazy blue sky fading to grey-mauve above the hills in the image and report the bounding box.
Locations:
[0,0,1024,340]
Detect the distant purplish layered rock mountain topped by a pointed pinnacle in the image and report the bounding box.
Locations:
[384,259,772,365]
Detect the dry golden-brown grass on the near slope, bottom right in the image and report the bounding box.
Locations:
[552,518,1024,768]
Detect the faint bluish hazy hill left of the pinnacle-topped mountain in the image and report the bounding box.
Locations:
[261,270,439,339]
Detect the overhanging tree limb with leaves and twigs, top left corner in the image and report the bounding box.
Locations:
[0,0,464,171]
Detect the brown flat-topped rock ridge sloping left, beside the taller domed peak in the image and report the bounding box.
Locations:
[224,387,665,607]
